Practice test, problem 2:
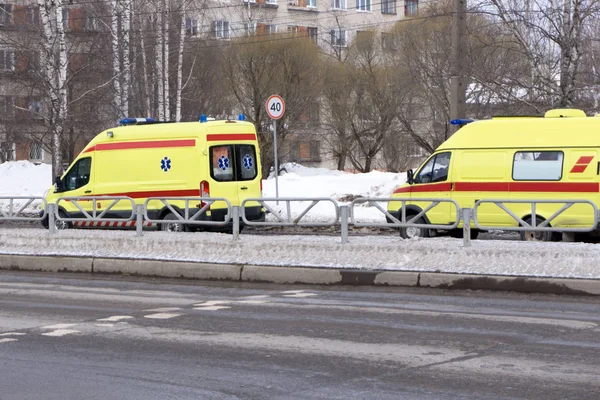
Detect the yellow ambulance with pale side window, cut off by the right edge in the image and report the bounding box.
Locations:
[388,109,600,241]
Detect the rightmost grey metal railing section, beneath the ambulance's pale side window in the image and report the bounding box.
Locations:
[472,199,598,232]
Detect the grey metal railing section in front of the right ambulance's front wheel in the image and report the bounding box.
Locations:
[350,197,461,230]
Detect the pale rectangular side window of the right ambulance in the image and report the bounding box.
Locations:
[513,151,563,181]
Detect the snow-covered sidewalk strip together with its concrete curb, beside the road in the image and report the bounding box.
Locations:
[0,229,600,295]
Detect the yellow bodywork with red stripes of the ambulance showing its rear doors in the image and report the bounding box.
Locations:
[46,121,261,223]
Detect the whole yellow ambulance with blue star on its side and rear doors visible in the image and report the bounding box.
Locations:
[44,115,264,231]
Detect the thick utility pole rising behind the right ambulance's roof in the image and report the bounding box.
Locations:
[450,0,467,130]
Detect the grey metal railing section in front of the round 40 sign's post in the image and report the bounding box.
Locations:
[240,197,340,227]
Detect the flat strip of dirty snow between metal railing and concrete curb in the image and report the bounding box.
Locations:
[0,229,600,279]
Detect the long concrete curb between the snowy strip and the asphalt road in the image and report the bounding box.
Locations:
[0,254,600,296]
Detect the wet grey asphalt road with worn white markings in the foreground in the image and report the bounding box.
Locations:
[0,271,600,400]
